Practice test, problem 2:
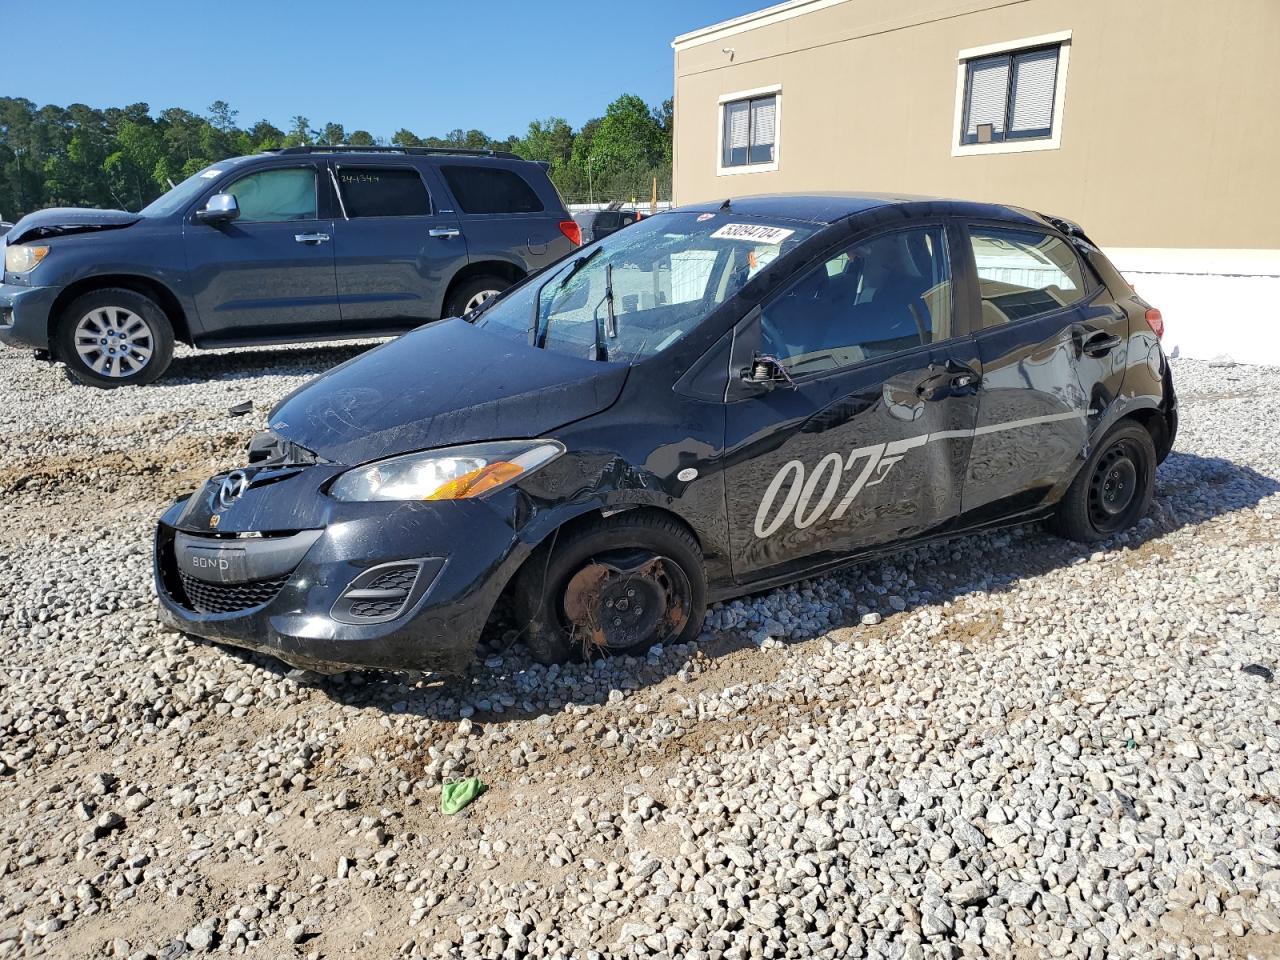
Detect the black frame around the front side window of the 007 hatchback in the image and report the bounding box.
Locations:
[746,221,977,384]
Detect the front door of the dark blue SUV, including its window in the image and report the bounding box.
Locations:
[183,163,339,342]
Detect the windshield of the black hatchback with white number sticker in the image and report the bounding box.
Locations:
[475,212,815,361]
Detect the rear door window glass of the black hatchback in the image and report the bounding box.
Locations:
[969,227,1088,329]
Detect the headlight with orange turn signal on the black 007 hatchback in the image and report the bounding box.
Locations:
[329,440,564,503]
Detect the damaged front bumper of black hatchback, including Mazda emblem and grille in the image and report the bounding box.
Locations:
[155,467,527,673]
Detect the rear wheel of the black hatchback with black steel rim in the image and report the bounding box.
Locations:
[1052,420,1156,543]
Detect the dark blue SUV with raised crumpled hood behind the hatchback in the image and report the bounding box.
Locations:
[0,147,581,387]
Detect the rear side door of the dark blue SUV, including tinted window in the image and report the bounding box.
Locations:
[329,159,467,330]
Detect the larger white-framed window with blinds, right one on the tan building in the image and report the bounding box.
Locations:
[952,33,1071,155]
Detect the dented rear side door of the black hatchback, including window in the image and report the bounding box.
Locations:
[964,223,1128,520]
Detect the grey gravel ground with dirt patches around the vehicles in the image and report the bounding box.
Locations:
[0,348,1280,960]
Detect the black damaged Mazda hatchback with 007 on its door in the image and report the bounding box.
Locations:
[155,196,1178,672]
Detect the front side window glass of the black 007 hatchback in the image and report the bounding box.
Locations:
[760,227,951,374]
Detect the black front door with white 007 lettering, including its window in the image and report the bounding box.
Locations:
[724,223,977,582]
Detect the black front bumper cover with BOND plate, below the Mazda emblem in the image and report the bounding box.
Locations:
[155,491,527,673]
